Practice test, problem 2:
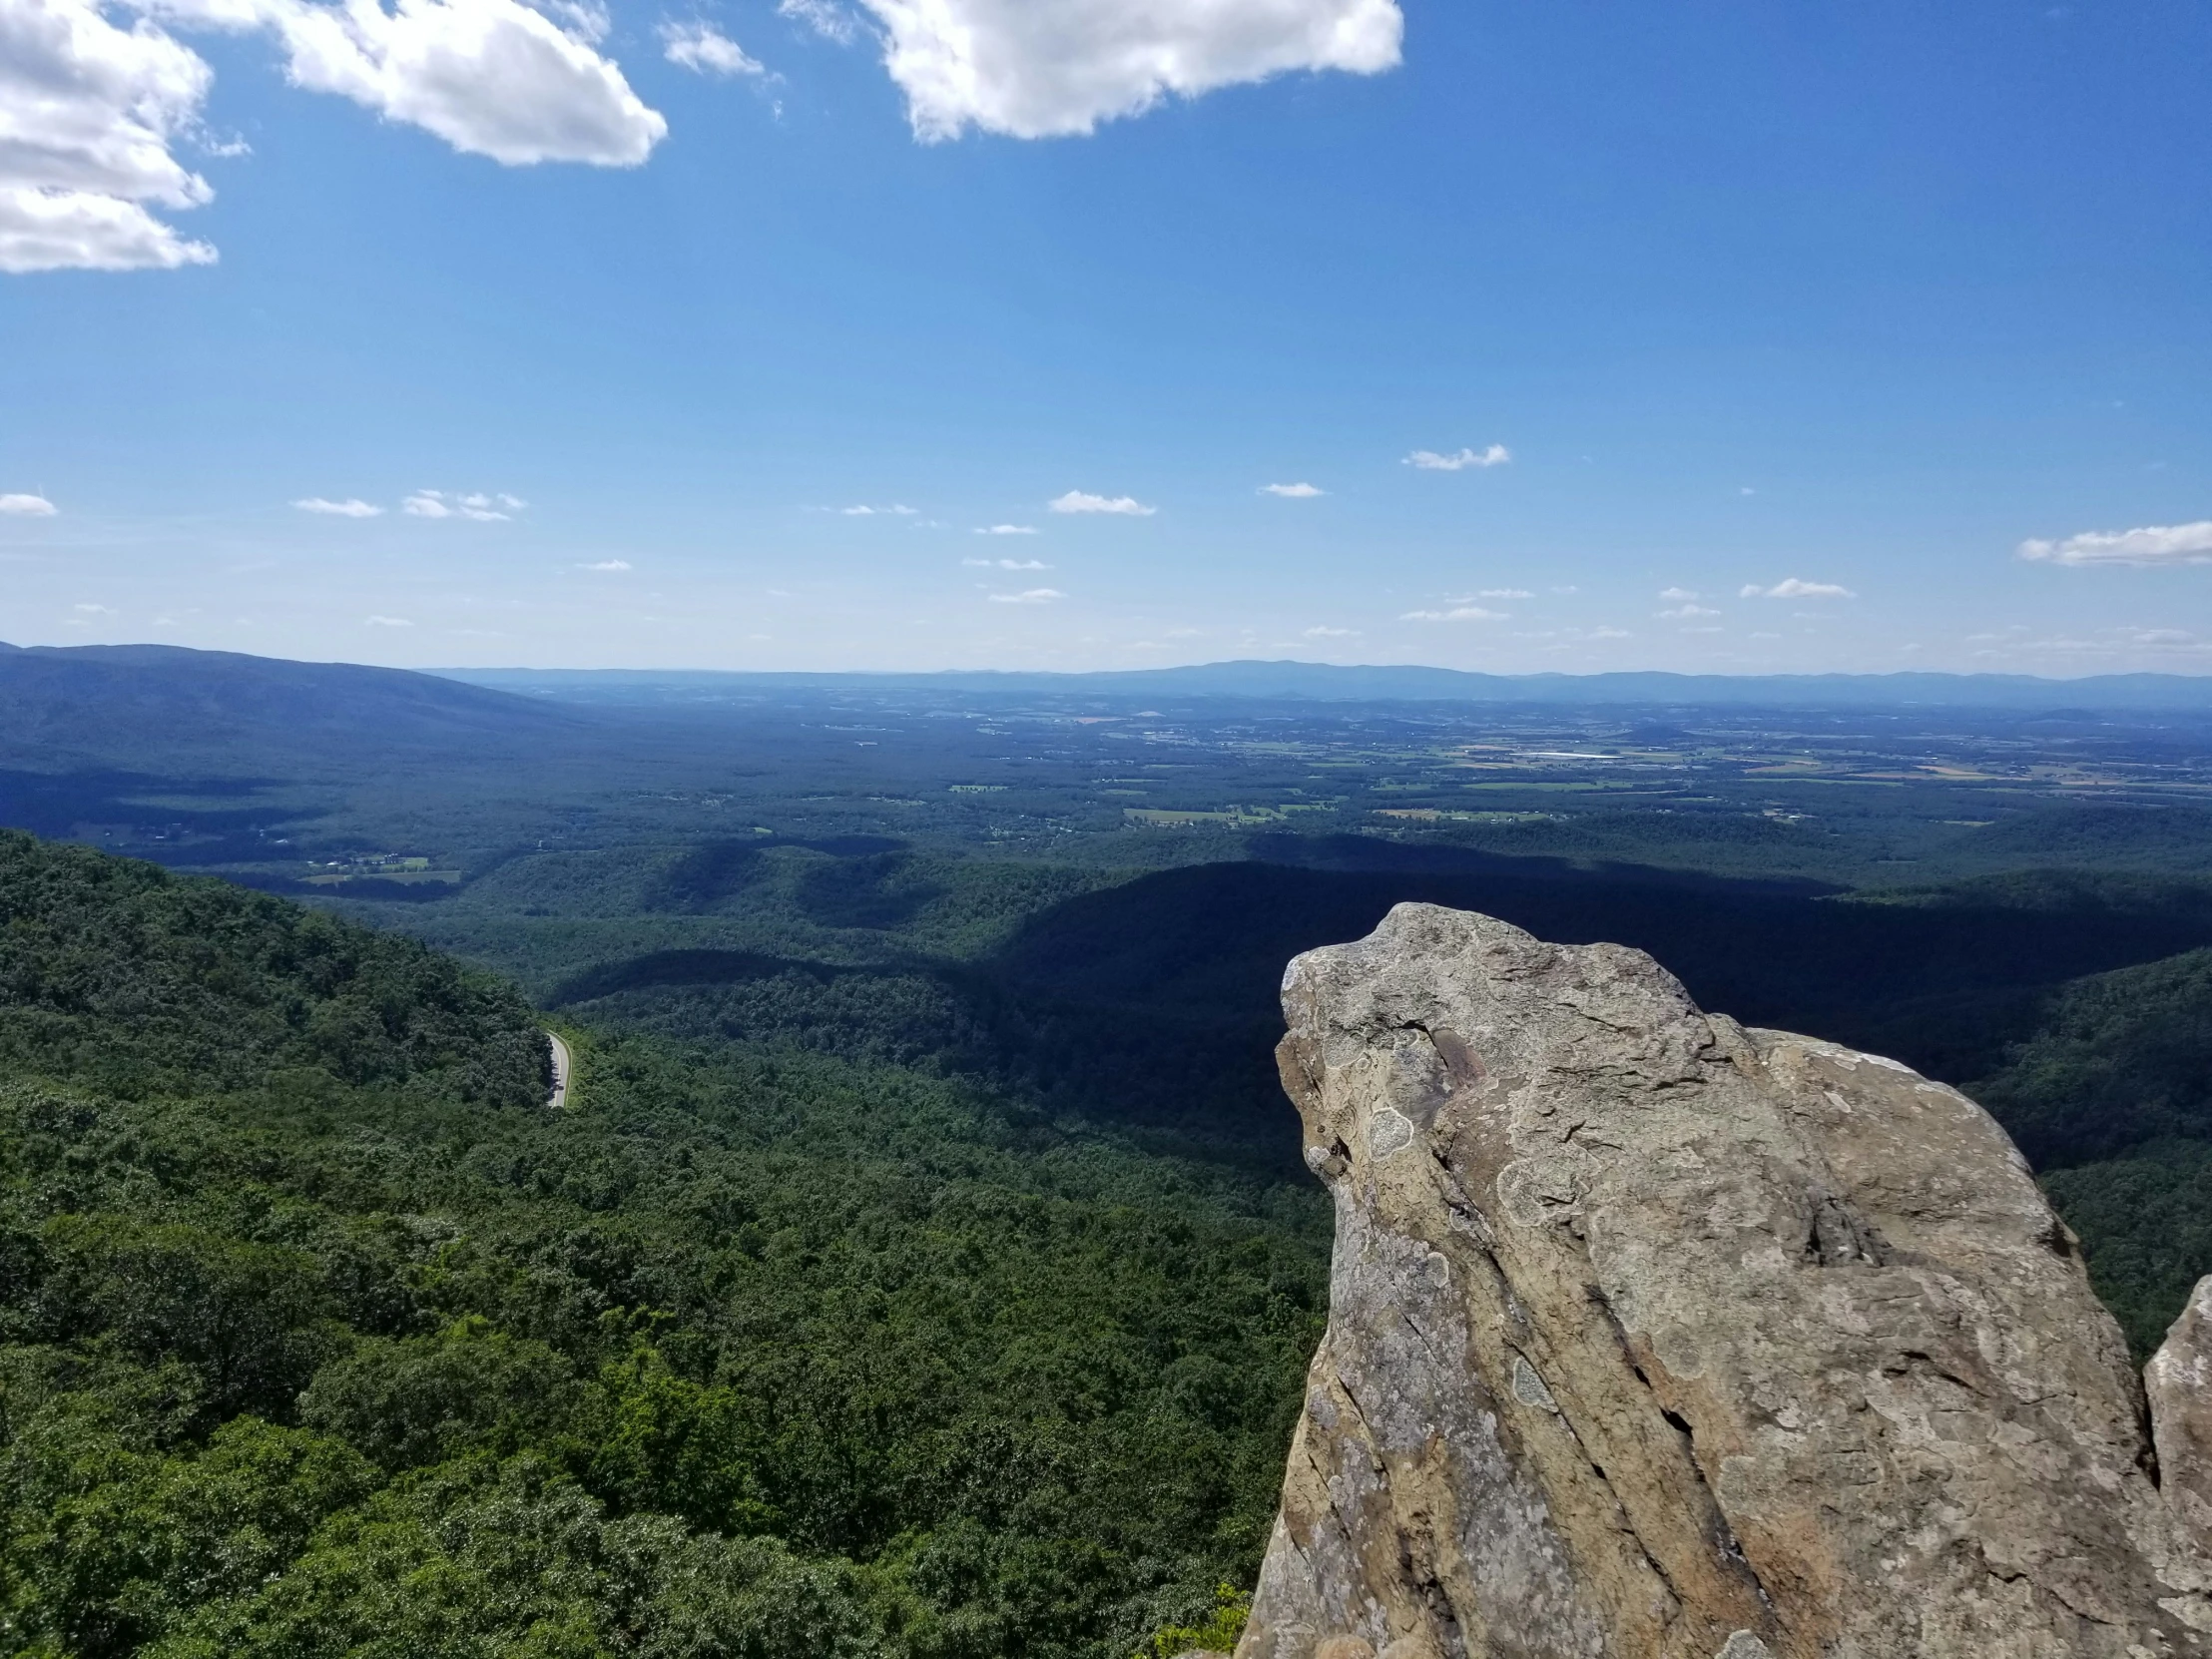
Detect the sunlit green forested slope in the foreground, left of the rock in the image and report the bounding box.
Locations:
[0,836,1328,1659]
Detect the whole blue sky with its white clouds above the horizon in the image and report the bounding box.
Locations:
[0,0,2212,675]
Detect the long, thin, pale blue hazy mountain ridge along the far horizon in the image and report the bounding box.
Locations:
[433,662,2212,710]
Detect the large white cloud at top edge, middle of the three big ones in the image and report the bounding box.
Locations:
[144,0,668,166]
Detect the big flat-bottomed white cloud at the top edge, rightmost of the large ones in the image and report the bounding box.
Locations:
[848,0,1404,142]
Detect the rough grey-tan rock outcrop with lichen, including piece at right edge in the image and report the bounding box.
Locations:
[1237,904,2212,1659]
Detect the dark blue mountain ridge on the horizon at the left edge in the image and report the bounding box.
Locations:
[0,644,588,759]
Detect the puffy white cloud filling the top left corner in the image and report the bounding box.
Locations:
[0,0,215,275]
